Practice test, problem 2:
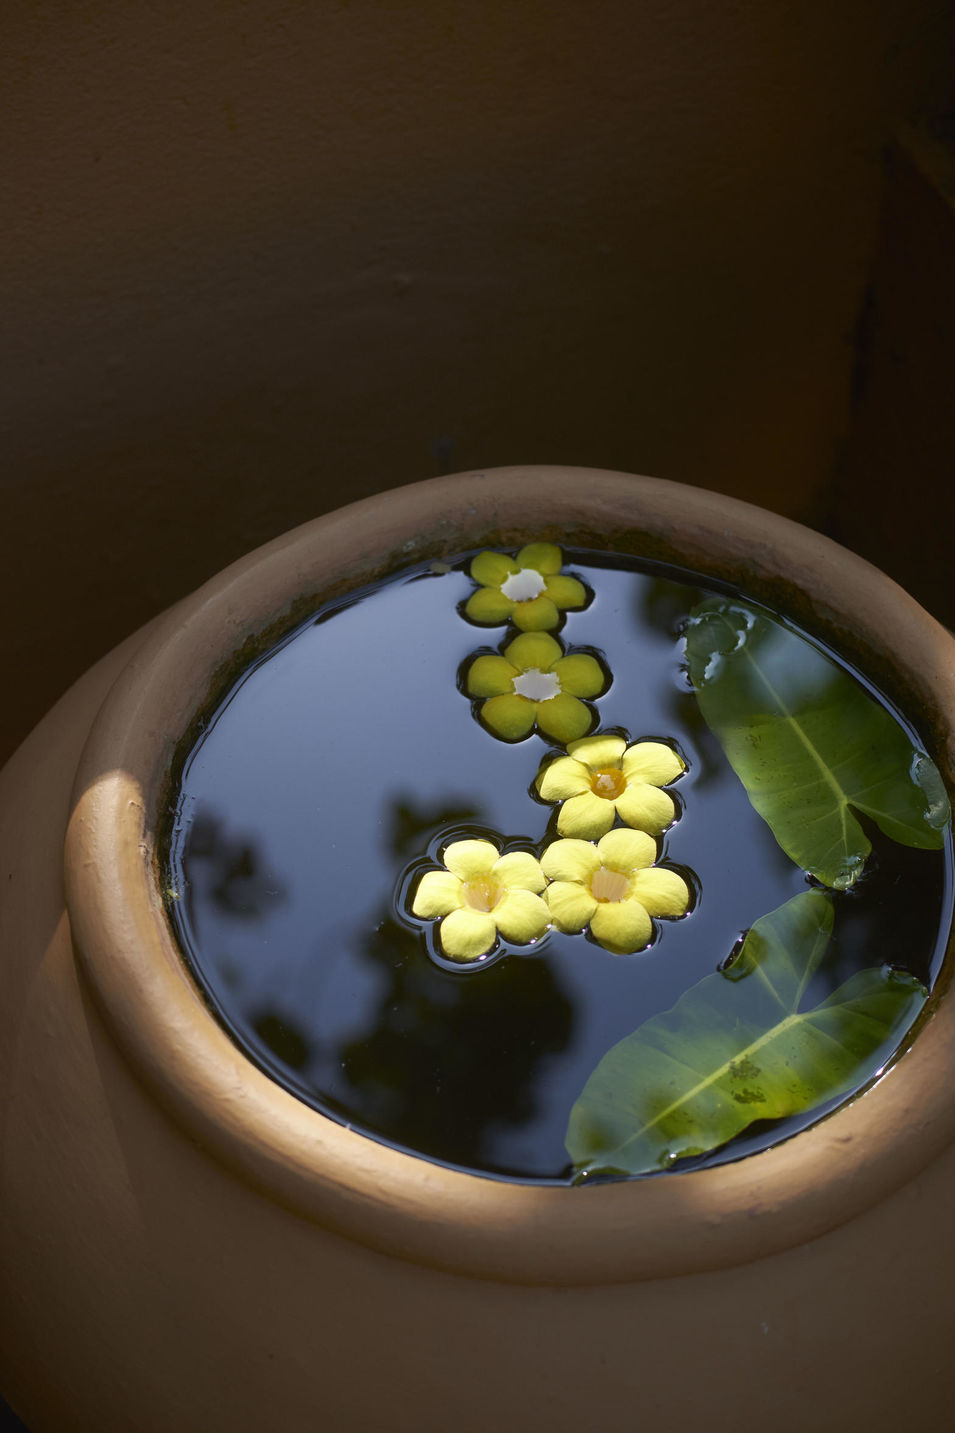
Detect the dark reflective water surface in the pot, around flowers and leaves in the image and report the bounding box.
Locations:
[168,553,952,1181]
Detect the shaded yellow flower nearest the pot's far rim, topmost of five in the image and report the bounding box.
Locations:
[465,542,586,632]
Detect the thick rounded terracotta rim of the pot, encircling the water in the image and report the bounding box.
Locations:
[65,467,955,1284]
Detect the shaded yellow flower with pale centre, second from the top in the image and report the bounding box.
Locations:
[467,632,605,742]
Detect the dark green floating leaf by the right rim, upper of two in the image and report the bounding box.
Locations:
[687,598,951,890]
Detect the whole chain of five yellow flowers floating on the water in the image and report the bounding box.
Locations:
[410,543,690,963]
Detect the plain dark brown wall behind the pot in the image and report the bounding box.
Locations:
[0,0,948,754]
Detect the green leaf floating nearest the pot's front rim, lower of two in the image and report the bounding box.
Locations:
[566,891,928,1175]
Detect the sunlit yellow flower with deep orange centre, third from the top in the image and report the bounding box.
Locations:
[536,737,685,841]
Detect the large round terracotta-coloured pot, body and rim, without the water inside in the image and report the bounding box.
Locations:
[0,467,955,1433]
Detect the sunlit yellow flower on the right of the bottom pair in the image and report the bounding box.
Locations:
[541,827,690,956]
